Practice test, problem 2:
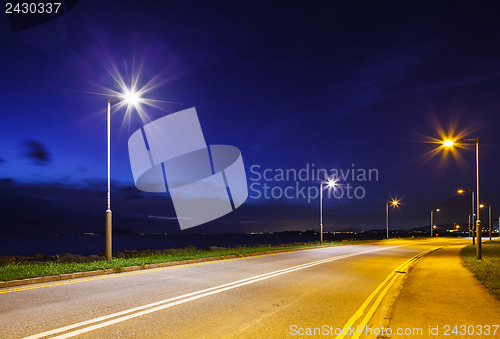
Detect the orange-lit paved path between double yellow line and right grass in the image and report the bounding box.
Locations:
[382,245,500,338]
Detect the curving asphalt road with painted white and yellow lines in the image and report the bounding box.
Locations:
[0,240,468,338]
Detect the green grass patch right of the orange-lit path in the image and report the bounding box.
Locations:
[461,241,500,299]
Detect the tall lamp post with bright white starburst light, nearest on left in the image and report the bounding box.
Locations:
[106,88,141,261]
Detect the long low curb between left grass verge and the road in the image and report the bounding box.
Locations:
[0,244,364,288]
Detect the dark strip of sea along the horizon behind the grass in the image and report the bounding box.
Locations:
[0,232,386,256]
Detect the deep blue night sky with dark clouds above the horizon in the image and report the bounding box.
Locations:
[0,0,500,238]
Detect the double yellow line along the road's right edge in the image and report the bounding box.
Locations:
[335,246,442,339]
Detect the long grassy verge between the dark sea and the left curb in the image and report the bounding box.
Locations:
[0,240,362,281]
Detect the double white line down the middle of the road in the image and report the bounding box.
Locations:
[24,245,404,339]
